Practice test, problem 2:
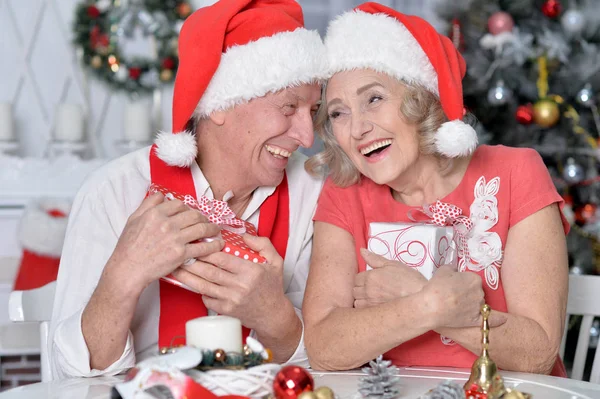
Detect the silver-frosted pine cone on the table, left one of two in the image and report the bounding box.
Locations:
[358,356,400,399]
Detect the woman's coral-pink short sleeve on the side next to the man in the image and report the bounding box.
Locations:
[313,178,352,234]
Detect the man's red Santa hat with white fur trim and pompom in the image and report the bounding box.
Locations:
[156,0,326,167]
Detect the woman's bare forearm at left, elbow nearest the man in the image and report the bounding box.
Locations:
[305,293,433,370]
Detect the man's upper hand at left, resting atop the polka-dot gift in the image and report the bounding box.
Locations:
[107,193,224,291]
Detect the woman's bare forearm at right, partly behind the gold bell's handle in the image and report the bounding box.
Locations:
[436,312,562,374]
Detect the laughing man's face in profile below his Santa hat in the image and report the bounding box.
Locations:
[210,84,321,186]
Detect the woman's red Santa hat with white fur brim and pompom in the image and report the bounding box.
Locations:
[325,2,477,158]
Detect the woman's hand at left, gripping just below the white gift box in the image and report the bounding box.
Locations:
[353,248,427,308]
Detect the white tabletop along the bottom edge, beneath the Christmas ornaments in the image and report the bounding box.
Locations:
[0,368,600,399]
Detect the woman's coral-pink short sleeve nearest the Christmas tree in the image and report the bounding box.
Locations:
[509,148,569,234]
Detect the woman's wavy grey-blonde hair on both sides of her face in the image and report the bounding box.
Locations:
[304,82,452,187]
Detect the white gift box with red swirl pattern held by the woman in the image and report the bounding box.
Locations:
[367,222,458,280]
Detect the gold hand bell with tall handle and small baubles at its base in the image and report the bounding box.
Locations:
[464,304,531,399]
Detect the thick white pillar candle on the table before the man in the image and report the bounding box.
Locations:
[185,316,242,353]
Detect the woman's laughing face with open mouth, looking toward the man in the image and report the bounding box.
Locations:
[326,69,420,184]
